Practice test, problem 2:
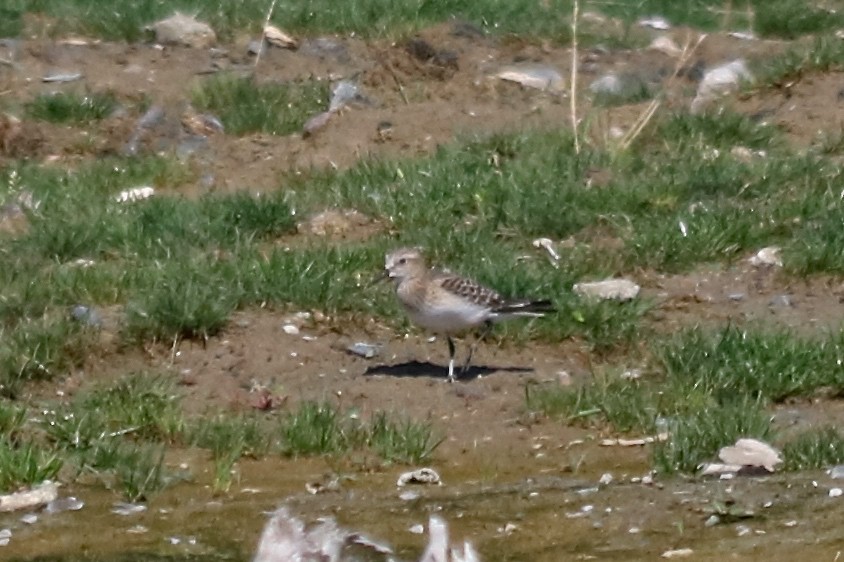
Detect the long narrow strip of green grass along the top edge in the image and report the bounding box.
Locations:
[12,0,763,44]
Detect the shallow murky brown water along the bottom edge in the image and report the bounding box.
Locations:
[0,449,844,562]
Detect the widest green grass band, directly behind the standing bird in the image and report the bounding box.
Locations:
[0,110,841,366]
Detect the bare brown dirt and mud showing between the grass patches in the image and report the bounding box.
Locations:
[0,20,844,560]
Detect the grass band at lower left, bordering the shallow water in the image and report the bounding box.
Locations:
[0,373,442,494]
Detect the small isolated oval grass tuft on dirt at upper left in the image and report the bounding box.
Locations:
[26,92,117,125]
